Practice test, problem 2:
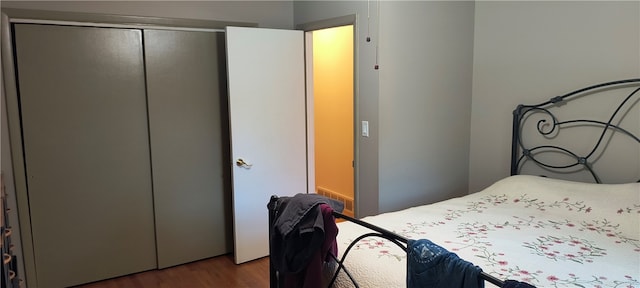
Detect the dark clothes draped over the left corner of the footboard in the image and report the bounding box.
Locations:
[270,194,344,287]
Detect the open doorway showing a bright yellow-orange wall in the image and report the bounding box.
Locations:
[306,25,355,216]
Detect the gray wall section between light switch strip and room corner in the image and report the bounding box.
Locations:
[379,1,474,212]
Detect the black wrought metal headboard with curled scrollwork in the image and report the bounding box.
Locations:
[511,79,640,183]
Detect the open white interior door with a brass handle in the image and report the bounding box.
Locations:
[226,27,307,264]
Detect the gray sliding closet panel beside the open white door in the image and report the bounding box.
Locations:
[144,30,231,268]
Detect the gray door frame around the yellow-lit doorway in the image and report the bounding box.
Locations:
[296,14,360,218]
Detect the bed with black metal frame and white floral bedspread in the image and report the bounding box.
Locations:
[268,79,640,287]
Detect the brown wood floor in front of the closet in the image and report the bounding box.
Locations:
[78,254,269,288]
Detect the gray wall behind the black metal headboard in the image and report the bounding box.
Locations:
[469,1,640,191]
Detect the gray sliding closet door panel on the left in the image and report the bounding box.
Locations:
[15,24,156,287]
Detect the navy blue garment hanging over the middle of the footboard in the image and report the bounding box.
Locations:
[407,239,484,288]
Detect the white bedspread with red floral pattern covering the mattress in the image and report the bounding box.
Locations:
[336,175,640,287]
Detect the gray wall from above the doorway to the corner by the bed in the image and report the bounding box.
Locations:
[294,1,474,216]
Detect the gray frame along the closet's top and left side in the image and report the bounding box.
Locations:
[0,8,258,287]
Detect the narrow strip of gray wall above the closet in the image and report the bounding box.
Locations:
[0,1,293,29]
